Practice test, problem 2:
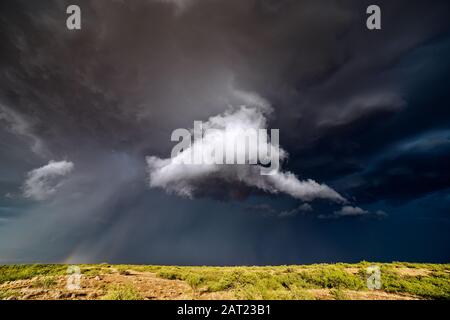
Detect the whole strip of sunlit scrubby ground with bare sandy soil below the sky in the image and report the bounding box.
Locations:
[0,262,450,300]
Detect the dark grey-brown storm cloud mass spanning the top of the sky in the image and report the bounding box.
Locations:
[1,1,447,153]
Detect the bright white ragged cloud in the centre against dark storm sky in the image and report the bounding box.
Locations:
[146,102,346,202]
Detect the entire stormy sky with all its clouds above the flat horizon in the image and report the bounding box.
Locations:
[0,0,450,265]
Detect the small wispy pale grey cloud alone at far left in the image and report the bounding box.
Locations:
[23,161,74,201]
